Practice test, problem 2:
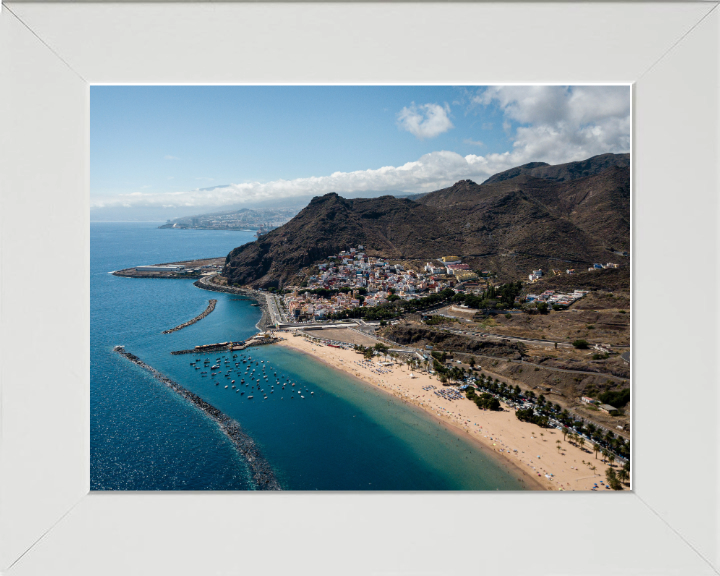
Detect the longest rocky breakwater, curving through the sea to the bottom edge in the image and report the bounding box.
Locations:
[113,346,282,490]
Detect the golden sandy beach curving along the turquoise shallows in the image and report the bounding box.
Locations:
[275,332,617,491]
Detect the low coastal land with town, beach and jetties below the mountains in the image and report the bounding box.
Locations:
[120,236,629,490]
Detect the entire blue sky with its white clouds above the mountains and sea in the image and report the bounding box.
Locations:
[90,86,630,218]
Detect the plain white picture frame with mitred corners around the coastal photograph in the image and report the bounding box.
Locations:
[0,2,720,576]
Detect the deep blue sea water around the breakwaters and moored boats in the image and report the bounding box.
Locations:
[90,222,523,490]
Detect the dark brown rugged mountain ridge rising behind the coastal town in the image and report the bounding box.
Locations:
[223,155,630,287]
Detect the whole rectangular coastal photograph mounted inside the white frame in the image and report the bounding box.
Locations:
[89,84,642,493]
